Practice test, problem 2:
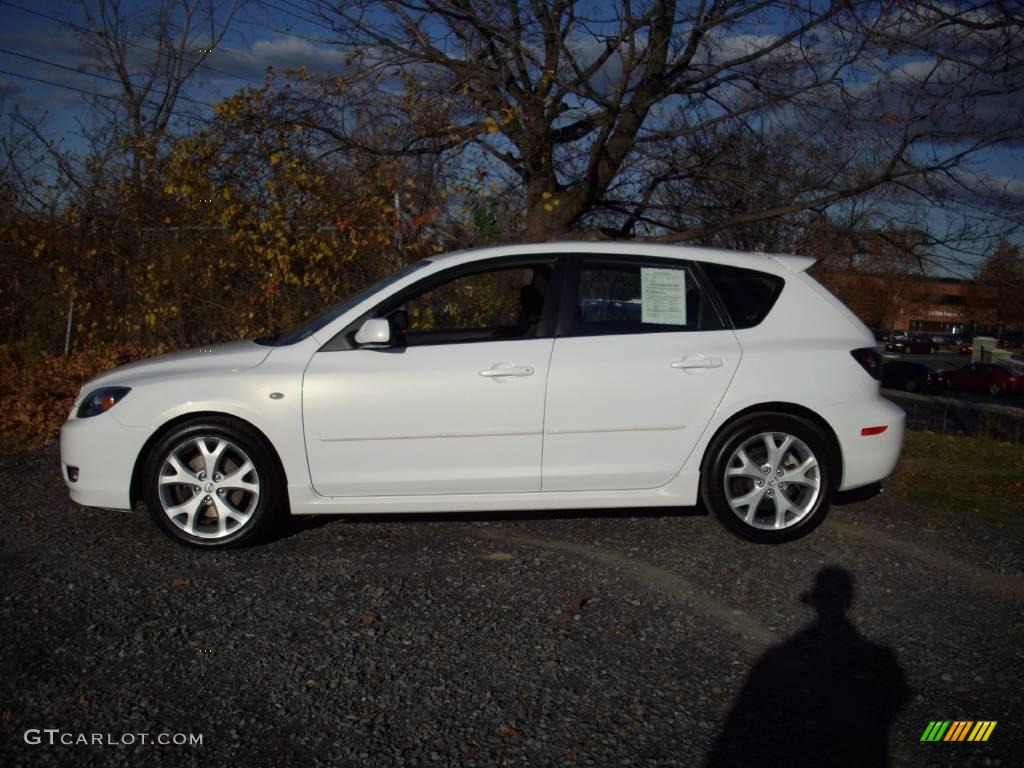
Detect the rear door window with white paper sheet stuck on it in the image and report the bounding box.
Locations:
[572,260,723,335]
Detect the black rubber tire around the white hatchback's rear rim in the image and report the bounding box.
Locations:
[700,413,837,544]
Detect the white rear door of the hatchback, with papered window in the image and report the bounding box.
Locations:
[542,256,740,492]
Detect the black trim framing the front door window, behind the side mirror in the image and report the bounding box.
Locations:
[317,252,566,352]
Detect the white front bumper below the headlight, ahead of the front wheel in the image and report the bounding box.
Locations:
[60,414,152,509]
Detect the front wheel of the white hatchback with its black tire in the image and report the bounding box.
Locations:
[142,417,286,549]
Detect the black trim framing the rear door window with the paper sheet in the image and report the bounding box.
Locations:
[556,253,733,338]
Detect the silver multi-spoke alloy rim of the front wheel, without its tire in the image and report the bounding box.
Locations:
[158,435,260,539]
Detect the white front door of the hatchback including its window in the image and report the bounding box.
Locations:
[303,262,553,497]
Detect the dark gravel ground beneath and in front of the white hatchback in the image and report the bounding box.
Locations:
[0,450,1024,768]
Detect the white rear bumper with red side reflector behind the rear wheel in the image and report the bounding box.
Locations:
[821,396,906,490]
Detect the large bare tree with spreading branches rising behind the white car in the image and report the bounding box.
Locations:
[280,0,1024,242]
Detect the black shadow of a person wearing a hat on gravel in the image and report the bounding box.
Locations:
[707,566,910,768]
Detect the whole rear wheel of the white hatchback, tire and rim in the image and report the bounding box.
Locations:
[701,414,831,544]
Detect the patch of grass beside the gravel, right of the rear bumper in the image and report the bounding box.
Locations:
[886,431,1024,523]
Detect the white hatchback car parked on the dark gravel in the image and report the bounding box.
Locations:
[60,243,904,547]
